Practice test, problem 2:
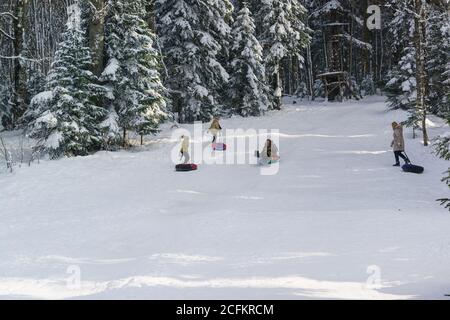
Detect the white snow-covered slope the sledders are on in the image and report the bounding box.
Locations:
[0,97,450,299]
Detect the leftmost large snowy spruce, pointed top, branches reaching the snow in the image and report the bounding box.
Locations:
[25,1,105,158]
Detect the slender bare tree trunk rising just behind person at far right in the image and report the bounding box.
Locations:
[414,0,428,146]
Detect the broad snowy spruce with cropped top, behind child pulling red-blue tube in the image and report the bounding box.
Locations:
[155,0,232,122]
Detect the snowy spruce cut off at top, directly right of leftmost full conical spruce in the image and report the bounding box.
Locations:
[102,0,167,146]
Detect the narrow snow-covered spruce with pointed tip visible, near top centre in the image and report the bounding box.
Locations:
[229,3,269,117]
